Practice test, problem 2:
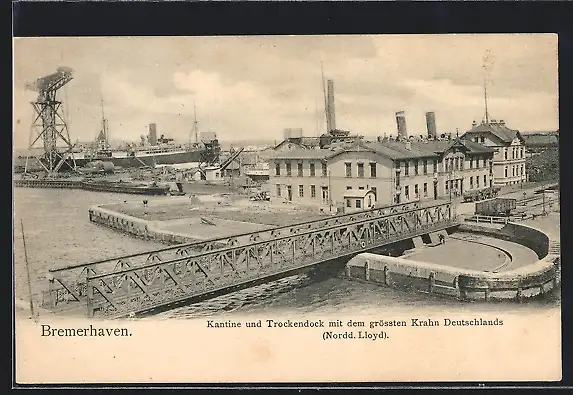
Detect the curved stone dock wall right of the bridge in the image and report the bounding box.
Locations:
[346,223,560,301]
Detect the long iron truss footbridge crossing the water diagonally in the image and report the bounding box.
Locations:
[43,202,458,318]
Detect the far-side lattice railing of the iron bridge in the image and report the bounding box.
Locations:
[43,202,419,308]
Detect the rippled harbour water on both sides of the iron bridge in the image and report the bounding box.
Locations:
[13,188,559,318]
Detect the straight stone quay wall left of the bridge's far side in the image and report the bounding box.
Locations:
[88,206,199,245]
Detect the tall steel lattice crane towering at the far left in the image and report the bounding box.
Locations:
[24,67,76,176]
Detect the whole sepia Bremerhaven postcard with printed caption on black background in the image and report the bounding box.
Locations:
[12,34,561,383]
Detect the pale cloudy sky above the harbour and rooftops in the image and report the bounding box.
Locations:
[13,34,559,148]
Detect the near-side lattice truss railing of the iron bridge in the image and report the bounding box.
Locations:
[87,203,458,317]
